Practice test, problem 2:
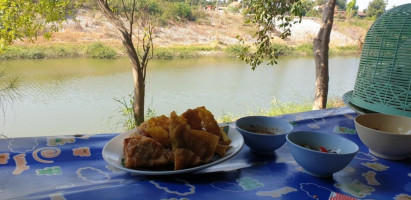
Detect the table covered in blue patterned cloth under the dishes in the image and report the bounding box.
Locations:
[0,107,411,200]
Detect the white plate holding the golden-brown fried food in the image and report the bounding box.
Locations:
[102,126,244,175]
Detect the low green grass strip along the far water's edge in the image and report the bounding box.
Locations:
[0,43,358,60]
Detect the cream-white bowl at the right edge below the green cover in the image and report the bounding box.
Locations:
[354,113,411,160]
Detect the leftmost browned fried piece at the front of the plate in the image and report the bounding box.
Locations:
[123,135,174,169]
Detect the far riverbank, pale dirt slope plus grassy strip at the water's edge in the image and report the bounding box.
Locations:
[0,11,372,60]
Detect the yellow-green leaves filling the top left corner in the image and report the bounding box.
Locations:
[0,0,74,51]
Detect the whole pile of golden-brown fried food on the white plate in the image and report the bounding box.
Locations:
[124,106,231,170]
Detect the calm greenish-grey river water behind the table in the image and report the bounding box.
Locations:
[0,57,359,137]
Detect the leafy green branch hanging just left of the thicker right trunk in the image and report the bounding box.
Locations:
[238,0,303,70]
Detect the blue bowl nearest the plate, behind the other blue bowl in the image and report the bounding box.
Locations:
[235,116,293,154]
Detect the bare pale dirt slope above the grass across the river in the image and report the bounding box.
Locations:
[25,11,366,46]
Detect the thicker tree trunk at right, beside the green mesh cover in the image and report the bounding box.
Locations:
[313,0,336,110]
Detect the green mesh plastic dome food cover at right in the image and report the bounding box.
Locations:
[351,4,411,117]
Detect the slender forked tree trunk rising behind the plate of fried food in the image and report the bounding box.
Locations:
[97,0,145,125]
